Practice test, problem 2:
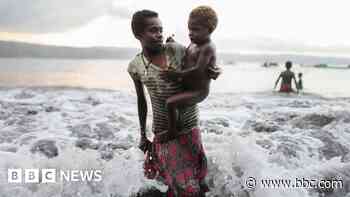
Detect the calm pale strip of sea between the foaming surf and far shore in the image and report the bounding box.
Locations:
[0,58,350,97]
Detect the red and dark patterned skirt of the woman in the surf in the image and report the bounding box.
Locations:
[144,128,209,197]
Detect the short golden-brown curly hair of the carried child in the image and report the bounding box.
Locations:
[190,6,218,33]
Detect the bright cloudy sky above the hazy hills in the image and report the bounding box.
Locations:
[0,0,350,57]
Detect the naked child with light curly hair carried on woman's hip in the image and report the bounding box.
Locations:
[166,6,220,137]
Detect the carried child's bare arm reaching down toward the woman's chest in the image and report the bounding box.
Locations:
[176,44,215,77]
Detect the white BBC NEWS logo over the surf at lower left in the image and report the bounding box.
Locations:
[7,169,102,183]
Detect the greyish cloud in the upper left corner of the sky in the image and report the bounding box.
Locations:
[0,0,129,33]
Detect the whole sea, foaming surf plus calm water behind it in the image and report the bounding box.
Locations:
[0,60,350,197]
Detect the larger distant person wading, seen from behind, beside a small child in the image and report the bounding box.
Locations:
[274,61,299,93]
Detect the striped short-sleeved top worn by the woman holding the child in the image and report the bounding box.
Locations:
[128,43,198,134]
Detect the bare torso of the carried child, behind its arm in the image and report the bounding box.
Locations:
[183,42,216,91]
